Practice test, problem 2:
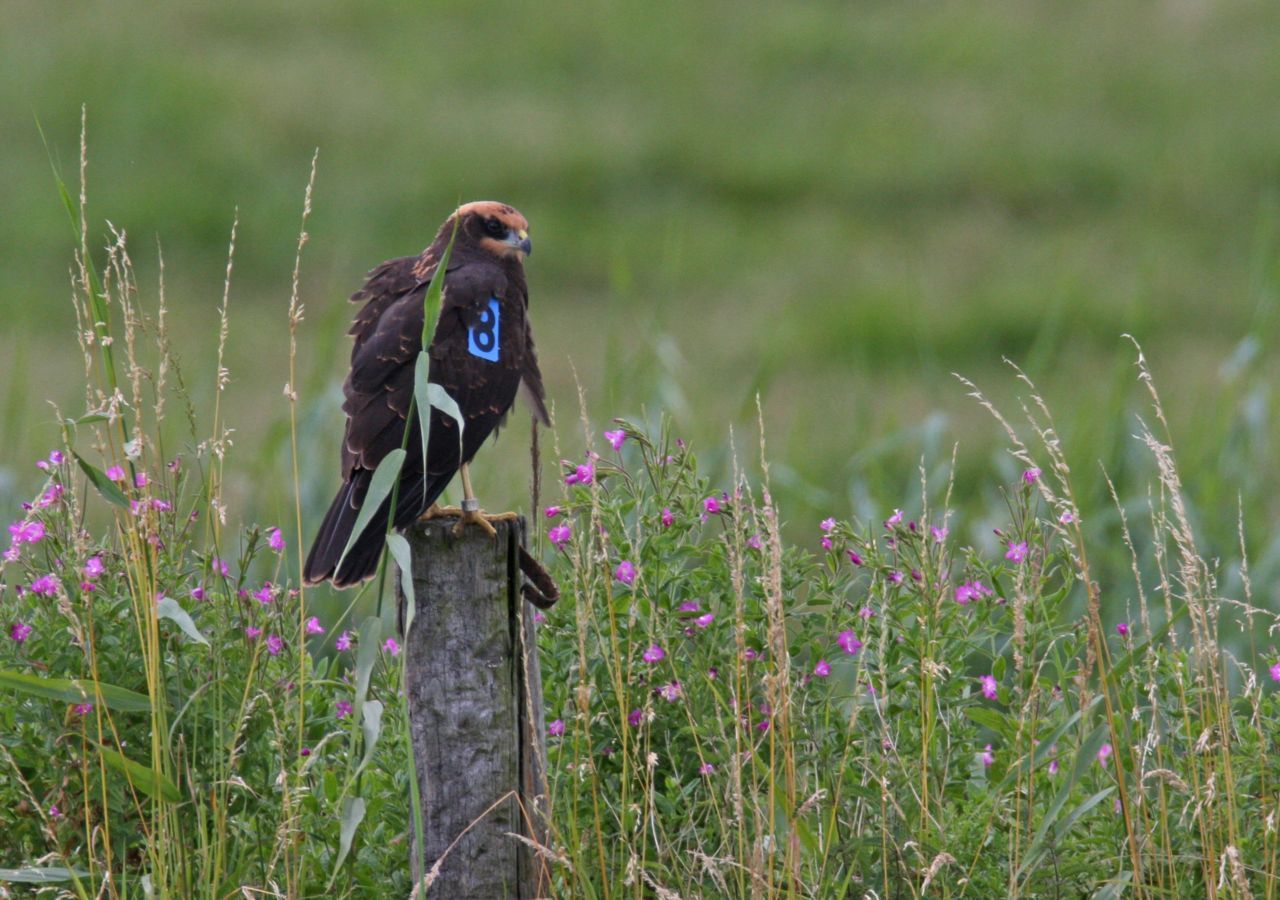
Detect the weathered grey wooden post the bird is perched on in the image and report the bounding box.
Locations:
[396,517,549,900]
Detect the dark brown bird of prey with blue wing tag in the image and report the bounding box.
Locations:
[311,201,549,588]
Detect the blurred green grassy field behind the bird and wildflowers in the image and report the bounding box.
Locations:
[0,0,1280,599]
